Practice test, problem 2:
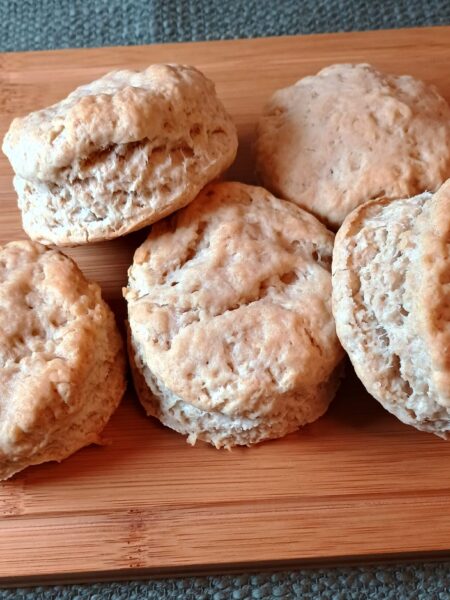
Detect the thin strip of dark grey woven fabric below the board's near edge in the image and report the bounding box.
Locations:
[0,564,450,600]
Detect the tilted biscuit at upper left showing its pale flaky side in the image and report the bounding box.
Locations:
[3,65,237,246]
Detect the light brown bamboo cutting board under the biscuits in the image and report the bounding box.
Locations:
[0,27,450,584]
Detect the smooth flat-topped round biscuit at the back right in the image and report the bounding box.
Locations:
[256,64,450,228]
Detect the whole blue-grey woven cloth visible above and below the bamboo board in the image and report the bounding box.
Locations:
[0,0,450,600]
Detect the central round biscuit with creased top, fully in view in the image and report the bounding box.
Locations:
[124,183,343,448]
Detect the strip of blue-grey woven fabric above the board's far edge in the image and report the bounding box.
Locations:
[0,0,450,51]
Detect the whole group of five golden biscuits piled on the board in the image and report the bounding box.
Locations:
[0,64,450,479]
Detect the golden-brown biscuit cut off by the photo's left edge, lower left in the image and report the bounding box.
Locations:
[0,242,125,479]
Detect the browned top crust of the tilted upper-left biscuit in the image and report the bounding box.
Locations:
[3,64,235,181]
